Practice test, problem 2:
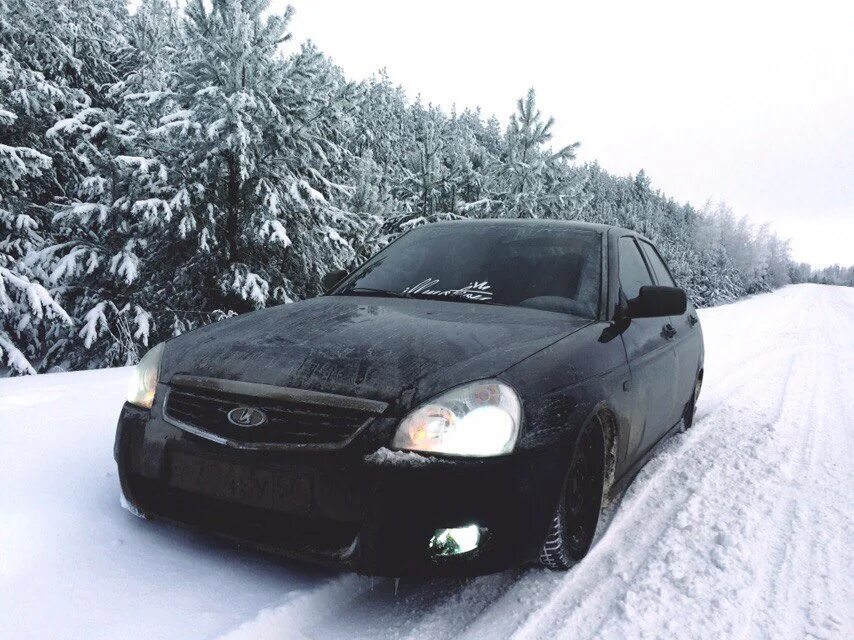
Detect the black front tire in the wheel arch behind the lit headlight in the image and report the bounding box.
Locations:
[540,416,605,571]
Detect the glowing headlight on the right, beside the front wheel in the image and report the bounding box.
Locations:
[392,380,522,457]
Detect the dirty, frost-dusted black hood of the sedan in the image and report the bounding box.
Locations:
[161,296,590,409]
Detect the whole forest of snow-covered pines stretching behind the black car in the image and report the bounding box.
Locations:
[0,0,854,374]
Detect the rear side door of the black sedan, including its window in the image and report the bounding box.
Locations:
[640,239,702,416]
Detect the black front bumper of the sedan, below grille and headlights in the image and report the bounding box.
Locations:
[114,404,565,576]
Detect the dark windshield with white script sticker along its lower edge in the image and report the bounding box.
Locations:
[333,223,601,318]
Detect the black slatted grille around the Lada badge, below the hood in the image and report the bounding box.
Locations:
[165,386,375,448]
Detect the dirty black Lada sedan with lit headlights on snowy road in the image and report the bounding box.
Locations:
[115,220,703,576]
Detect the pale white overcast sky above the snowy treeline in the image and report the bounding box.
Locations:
[273,0,854,265]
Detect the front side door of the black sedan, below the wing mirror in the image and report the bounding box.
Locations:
[618,236,676,452]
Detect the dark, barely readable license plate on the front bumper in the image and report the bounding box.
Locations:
[169,451,311,515]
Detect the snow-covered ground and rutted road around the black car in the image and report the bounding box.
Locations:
[0,285,854,640]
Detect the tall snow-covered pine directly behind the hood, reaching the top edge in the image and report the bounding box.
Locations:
[166,0,370,304]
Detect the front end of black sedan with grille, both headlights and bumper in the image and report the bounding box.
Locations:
[115,347,562,576]
